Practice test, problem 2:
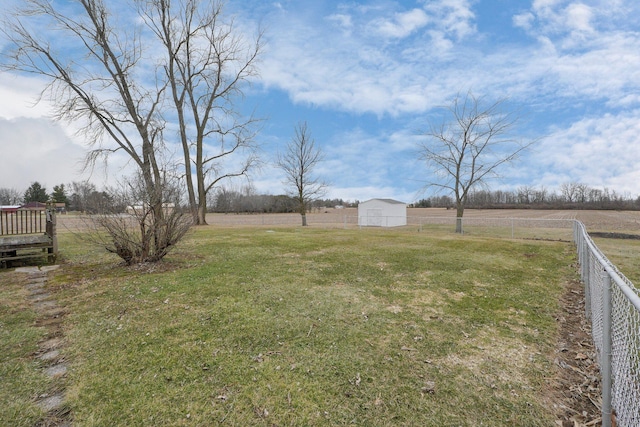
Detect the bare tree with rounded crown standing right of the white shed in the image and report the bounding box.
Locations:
[419,92,534,233]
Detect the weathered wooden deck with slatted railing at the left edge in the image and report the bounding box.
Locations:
[0,208,58,268]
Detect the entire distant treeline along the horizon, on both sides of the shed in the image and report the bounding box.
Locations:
[0,182,640,213]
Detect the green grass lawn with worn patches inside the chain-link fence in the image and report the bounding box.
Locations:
[0,226,576,427]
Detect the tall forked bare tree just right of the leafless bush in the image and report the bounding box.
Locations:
[142,0,261,224]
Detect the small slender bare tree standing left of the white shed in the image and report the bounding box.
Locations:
[277,122,326,226]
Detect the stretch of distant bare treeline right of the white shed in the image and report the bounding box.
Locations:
[411,183,640,210]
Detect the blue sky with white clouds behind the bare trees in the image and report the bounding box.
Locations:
[0,0,640,203]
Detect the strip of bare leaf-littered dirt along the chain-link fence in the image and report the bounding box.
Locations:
[549,280,602,427]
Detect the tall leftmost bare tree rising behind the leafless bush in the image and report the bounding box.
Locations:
[1,0,191,262]
